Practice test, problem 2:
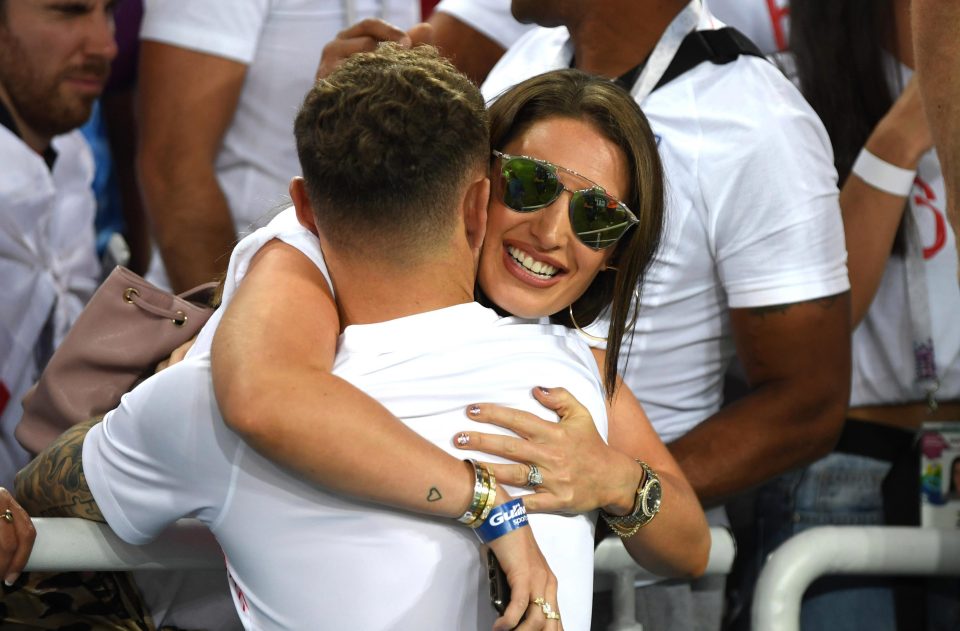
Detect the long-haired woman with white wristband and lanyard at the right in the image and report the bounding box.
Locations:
[757,0,960,631]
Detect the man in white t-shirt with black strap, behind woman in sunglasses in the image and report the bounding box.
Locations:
[483,0,850,629]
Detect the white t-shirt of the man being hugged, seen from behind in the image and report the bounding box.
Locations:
[83,211,607,631]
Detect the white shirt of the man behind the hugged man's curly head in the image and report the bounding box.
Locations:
[140,0,420,284]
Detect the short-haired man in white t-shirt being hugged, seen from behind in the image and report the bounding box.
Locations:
[18,47,606,631]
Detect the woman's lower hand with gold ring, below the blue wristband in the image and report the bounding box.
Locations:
[490,506,563,631]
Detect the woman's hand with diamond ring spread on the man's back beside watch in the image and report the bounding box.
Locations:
[454,388,642,514]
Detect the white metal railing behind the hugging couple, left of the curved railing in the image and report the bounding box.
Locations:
[26,518,736,631]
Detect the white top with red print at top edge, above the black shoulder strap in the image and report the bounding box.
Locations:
[707,0,790,55]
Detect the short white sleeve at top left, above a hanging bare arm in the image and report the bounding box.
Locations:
[140,0,270,65]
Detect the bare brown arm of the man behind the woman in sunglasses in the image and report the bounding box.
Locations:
[669,293,850,506]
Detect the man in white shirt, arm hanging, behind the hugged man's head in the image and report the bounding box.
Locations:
[138,0,420,291]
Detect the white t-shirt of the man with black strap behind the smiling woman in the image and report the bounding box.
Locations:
[483,7,850,442]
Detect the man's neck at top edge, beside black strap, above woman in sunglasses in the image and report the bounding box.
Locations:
[567,0,687,79]
